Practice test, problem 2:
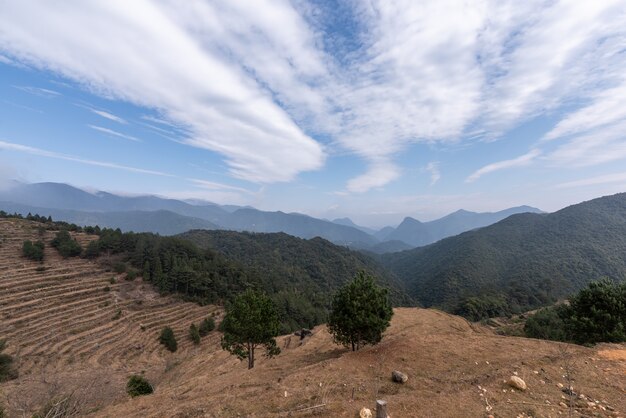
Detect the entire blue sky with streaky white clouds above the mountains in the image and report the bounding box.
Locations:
[0,0,626,227]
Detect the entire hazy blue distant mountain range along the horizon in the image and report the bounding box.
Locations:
[0,182,540,254]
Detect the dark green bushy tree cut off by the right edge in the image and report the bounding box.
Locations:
[568,278,626,344]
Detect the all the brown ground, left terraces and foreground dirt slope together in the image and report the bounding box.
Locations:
[0,220,626,418]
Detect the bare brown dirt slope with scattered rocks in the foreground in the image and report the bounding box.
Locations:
[96,308,626,418]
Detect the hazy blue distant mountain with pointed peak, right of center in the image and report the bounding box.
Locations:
[377,206,541,247]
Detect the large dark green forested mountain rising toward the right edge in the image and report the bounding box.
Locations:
[381,193,626,311]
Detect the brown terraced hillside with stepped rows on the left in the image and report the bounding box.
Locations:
[0,219,218,416]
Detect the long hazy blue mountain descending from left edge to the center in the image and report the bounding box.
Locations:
[0,183,378,248]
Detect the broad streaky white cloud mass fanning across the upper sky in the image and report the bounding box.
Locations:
[0,0,626,192]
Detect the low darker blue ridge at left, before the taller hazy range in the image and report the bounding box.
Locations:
[0,202,219,235]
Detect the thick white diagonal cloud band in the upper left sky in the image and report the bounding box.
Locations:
[0,0,324,182]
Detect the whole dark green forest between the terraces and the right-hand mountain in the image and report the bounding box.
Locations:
[84,229,410,332]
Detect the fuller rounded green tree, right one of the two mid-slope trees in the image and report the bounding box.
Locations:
[328,272,393,351]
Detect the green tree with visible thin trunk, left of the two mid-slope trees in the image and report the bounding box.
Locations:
[221,289,280,369]
